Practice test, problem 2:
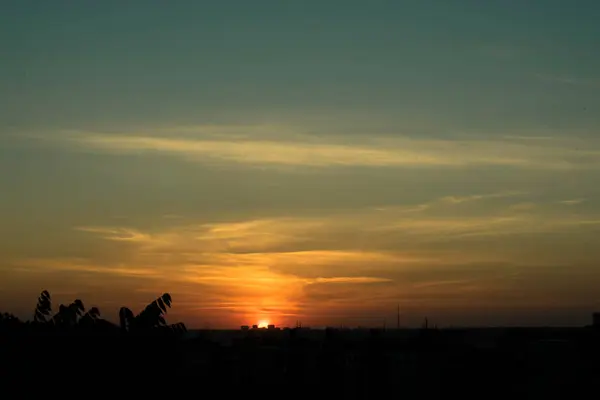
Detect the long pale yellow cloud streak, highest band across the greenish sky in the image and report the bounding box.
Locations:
[35,127,600,169]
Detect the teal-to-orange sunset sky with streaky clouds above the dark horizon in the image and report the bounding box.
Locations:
[0,0,600,328]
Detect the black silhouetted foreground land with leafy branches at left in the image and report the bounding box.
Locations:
[0,291,600,399]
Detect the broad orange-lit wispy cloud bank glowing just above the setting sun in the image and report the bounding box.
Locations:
[12,202,600,326]
